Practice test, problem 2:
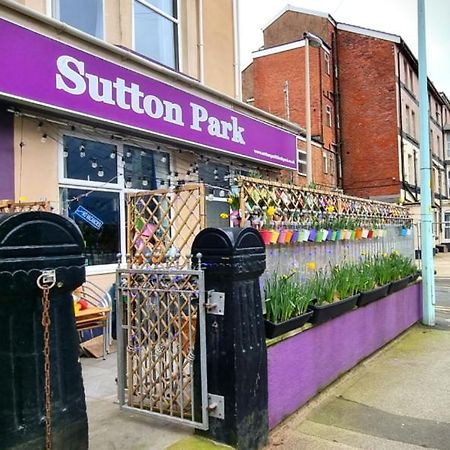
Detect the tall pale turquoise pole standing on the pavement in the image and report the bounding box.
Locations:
[417,0,435,326]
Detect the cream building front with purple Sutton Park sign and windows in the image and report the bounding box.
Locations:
[0,0,300,287]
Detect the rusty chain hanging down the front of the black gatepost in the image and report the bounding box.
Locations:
[41,287,52,450]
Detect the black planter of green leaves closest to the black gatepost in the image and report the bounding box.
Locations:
[264,272,313,338]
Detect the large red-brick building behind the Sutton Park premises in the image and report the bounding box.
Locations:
[243,6,450,246]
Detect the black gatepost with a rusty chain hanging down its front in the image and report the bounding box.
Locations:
[0,211,88,450]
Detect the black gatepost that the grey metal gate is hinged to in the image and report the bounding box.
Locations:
[192,228,268,450]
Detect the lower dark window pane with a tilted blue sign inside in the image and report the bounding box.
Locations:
[61,188,120,266]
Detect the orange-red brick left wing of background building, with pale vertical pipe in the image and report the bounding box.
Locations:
[242,7,341,189]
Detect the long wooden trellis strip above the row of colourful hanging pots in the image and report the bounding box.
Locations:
[238,177,410,224]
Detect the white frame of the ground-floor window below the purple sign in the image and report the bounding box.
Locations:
[57,129,174,275]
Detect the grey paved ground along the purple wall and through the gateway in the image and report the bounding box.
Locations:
[82,253,450,450]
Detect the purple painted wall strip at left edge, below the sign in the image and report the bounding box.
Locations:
[0,104,14,200]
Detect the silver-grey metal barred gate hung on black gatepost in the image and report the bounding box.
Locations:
[116,268,208,429]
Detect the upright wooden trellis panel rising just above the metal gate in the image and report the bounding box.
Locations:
[127,184,205,267]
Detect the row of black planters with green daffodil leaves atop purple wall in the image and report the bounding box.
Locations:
[264,252,417,338]
